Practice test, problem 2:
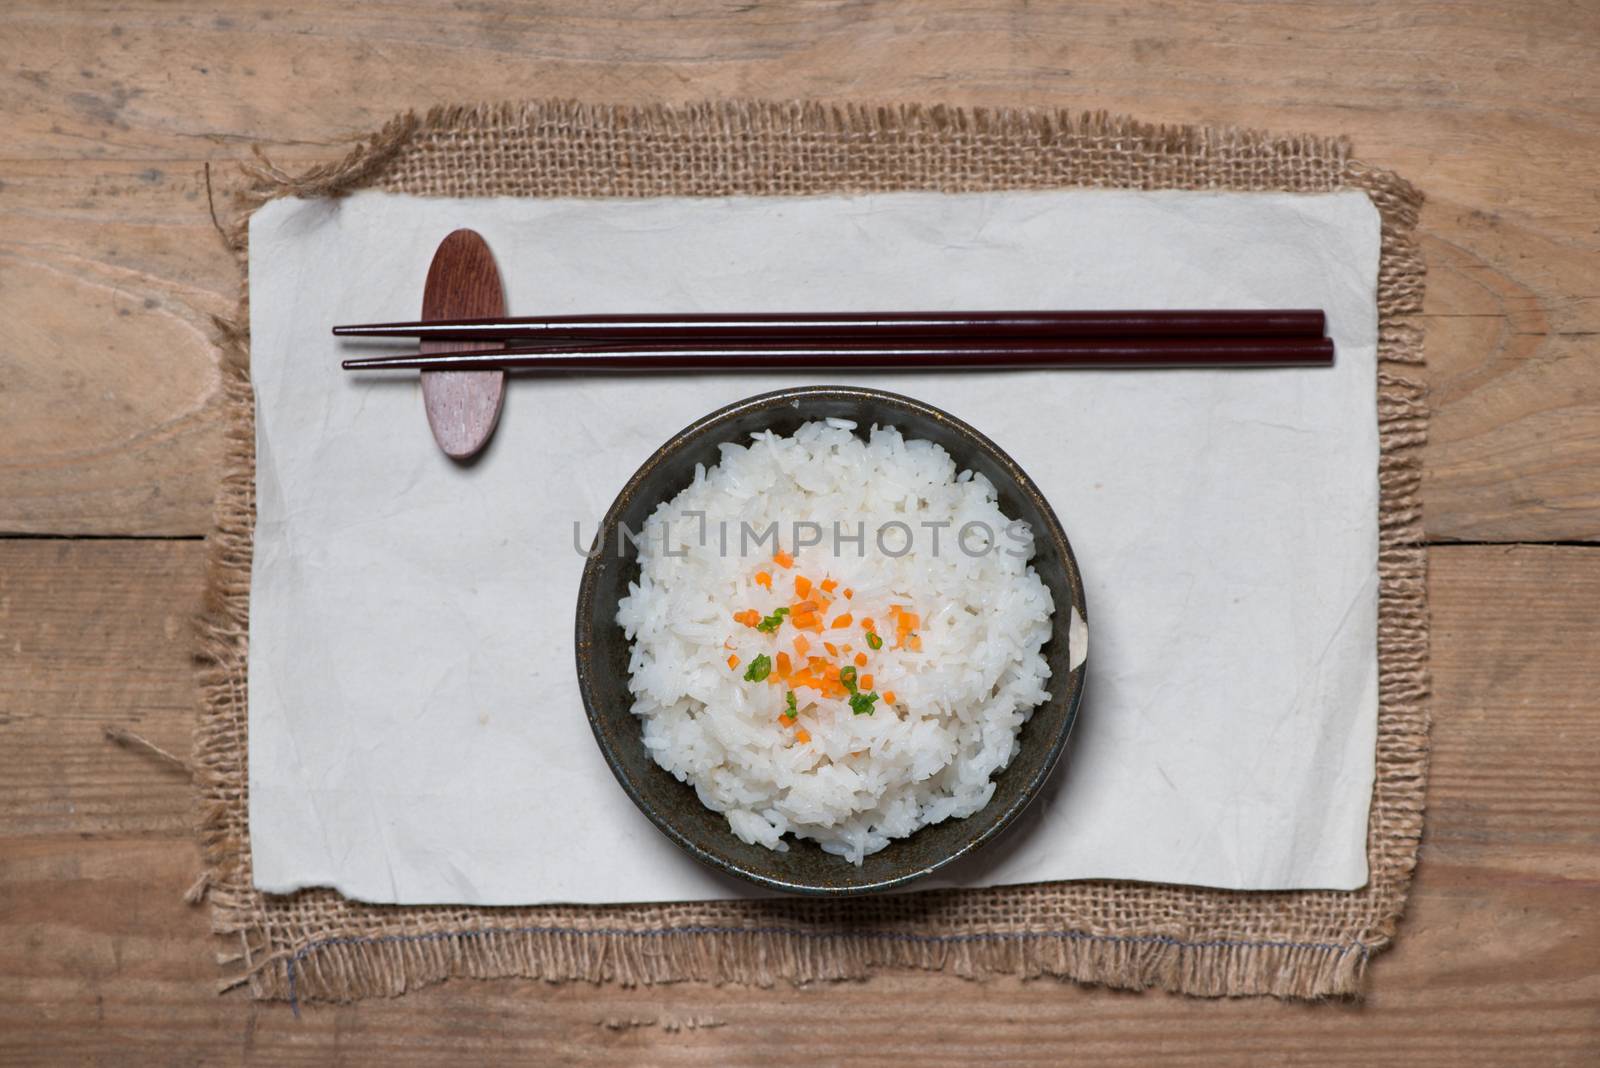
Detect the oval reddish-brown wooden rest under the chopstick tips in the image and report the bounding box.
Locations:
[422,230,506,460]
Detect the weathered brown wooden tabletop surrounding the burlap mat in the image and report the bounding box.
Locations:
[0,0,1600,1068]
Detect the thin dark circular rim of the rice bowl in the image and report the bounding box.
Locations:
[574,385,1088,897]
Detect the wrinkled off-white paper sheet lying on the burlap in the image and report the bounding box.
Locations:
[250,192,1378,905]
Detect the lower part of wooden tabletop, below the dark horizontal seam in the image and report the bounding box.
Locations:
[0,540,1600,1068]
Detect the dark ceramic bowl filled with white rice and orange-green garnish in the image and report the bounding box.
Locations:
[576,387,1088,895]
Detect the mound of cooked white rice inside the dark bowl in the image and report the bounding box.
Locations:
[618,419,1053,863]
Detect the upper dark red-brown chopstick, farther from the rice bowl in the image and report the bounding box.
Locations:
[333,309,1326,344]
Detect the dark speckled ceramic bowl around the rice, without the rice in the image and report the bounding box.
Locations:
[576,385,1088,895]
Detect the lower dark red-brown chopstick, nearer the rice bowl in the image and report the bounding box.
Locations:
[342,337,1333,373]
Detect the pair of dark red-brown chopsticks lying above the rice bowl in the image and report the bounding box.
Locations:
[333,309,1333,371]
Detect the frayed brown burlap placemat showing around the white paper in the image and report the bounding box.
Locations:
[195,95,1427,1002]
